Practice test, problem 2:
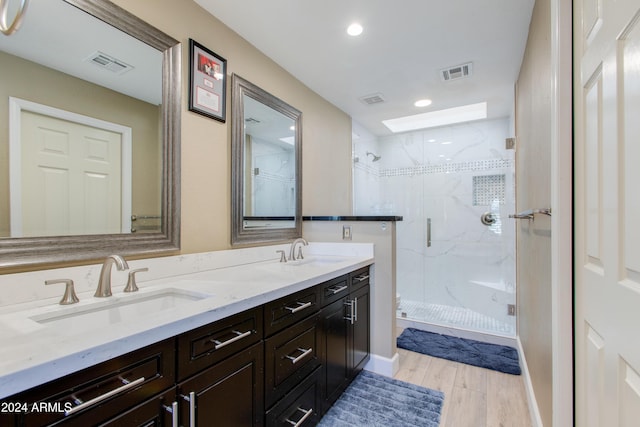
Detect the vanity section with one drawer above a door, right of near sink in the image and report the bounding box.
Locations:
[177,307,264,427]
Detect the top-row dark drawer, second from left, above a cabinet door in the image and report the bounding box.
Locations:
[178,307,263,381]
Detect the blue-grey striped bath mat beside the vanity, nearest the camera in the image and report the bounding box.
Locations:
[318,371,444,427]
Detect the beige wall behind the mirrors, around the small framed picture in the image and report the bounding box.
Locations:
[114,0,351,253]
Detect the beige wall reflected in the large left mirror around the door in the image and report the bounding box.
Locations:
[0,52,161,237]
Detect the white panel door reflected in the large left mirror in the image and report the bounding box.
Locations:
[21,111,122,236]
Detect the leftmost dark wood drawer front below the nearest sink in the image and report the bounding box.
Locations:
[7,339,175,426]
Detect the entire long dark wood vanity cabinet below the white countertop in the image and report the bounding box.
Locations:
[0,267,370,427]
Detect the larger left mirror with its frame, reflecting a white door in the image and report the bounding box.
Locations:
[0,0,181,267]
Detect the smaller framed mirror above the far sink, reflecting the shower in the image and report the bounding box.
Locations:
[231,74,302,245]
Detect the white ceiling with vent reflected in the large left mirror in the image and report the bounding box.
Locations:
[0,0,162,105]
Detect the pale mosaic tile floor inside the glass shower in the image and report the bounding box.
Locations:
[396,300,515,335]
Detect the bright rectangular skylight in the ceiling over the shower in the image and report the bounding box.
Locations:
[382,102,487,133]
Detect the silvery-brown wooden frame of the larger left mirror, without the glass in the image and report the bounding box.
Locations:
[0,0,182,267]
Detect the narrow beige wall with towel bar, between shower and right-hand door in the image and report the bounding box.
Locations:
[516,0,553,426]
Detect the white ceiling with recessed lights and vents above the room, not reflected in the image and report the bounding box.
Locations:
[195,0,535,135]
